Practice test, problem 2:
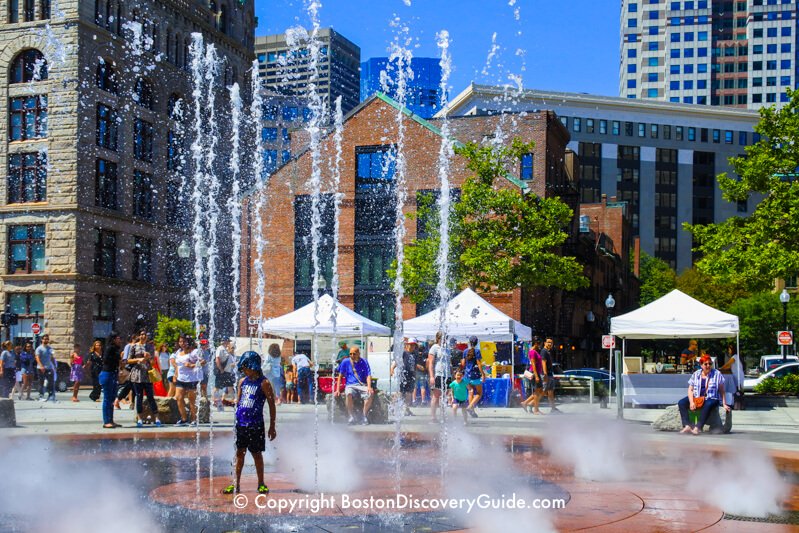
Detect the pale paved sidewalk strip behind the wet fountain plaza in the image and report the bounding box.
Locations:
[6,390,799,452]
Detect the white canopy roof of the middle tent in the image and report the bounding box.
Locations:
[403,289,532,341]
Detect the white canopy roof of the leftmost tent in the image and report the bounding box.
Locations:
[259,294,391,339]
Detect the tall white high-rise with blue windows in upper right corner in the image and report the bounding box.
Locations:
[619,0,798,109]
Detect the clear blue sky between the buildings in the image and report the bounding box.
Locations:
[255,0,620,96]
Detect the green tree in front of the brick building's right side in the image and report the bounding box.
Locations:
[398,139,588,303]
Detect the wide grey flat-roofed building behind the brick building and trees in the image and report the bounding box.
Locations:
[440,85,759,271]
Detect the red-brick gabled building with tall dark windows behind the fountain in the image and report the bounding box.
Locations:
[241,95,636,364]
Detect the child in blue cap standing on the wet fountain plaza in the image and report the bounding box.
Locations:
[222,352,277,494]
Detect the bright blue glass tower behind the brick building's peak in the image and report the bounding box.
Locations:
[361,57,444,119]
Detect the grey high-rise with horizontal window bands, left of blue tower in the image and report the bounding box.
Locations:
[255,28,361,115]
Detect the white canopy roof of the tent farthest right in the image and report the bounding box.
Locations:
[610,289,738,339]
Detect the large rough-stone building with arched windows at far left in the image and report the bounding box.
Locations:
[0,0,255,357]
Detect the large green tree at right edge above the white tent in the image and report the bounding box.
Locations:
[685,90,799,291]
